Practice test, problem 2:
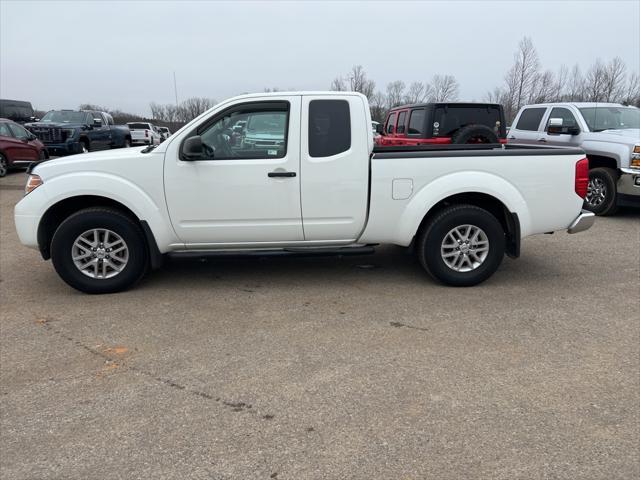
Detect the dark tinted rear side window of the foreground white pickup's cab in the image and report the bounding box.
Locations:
[309,100,351,157]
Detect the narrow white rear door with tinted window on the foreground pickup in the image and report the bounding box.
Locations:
[300,95,371,241]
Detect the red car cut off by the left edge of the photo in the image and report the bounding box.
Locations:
[0,118,49,177]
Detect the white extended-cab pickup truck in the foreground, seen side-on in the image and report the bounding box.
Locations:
[15,92,594,293]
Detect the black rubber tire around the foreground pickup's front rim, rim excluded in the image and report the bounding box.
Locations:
[51,207,149,293]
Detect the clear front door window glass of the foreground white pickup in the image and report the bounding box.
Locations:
[199,102,289,160]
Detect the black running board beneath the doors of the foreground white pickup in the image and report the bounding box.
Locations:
[167,245,375,258]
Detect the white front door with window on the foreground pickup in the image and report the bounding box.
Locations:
[164,96,304,249]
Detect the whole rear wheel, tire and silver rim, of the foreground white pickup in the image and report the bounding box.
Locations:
[418,205,505,287]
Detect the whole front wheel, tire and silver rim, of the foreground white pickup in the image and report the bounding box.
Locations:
[51,208,148,293]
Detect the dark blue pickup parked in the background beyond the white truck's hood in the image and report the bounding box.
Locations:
[25,110,131,155]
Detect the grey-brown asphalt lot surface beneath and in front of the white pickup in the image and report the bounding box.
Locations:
[0,174,640,480]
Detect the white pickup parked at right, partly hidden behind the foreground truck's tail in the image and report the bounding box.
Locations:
[508,102,640,215]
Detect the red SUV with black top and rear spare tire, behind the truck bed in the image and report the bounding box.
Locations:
[376,103,507,146]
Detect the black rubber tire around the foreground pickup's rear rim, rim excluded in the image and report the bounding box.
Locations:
[417,205,505,287]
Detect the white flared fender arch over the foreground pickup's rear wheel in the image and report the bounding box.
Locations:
[397,171,531,243]
